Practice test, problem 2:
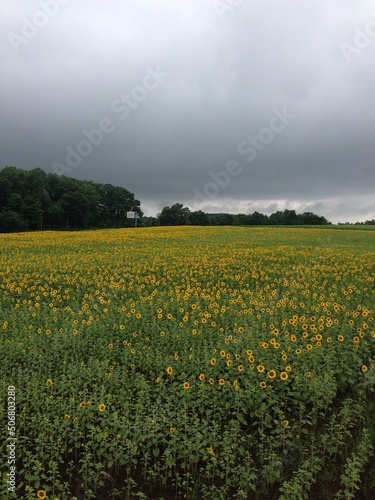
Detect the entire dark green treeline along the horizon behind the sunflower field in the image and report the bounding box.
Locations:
[0,167,375,233]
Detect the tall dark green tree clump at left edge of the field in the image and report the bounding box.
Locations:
[0,167,143,232]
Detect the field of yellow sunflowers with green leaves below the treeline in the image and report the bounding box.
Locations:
[0,227,375,500]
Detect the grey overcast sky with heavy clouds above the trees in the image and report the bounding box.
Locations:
[0,0,375,222]
